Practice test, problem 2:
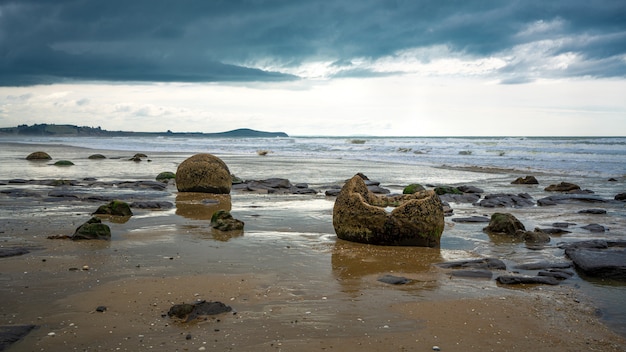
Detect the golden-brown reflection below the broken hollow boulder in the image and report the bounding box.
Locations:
[331,239,443,294]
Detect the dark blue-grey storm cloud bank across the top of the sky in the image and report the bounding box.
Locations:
[0,0,626,86]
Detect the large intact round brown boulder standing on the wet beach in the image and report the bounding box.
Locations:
[176,153,232,194]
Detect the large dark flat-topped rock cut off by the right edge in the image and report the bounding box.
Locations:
[565,247,626,280]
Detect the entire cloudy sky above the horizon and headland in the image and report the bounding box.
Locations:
[0,0,626,136]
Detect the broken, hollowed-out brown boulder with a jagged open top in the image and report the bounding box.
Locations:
[333,175,444,247]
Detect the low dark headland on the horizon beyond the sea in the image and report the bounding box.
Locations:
[0,123,289,138]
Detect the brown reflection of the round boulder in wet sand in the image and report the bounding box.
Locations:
[176,192,232,220]
